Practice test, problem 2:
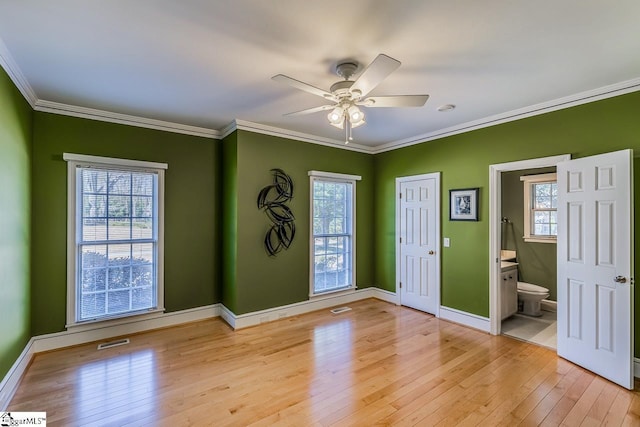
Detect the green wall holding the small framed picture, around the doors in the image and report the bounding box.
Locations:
[375,92,640,348]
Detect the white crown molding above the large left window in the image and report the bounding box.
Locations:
[34,99,220,139]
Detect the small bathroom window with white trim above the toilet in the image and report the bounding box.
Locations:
[520,173,558,243]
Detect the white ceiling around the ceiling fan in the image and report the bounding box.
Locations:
[0,0,640,150]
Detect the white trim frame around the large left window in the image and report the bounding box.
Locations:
[62,153,169,328]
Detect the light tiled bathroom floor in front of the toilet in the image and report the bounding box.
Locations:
[502,310,557,350]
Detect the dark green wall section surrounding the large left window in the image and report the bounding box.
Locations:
[31,112,220,335]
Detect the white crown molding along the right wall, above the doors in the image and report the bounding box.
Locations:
[372,78,640,154]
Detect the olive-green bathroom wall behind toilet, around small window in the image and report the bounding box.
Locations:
[502,168,557,301]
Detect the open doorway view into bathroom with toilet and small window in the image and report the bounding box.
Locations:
[500,166,557,350]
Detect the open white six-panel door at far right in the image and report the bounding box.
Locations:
[558,150,633,389]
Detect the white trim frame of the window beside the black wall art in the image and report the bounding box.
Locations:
[309,170,362,299]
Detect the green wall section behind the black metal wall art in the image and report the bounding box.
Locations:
[223,131,375,314]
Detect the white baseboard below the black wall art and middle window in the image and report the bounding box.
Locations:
[220,287,397,329]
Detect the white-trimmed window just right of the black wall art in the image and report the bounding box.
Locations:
[309,171,361,296]
